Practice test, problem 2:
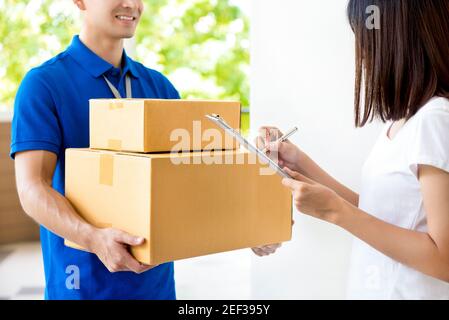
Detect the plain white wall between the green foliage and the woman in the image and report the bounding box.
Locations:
[251,0,379,299]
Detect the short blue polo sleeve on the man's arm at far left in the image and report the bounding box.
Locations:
[10,69,62,159]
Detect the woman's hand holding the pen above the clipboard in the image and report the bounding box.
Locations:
[256,127,303,171]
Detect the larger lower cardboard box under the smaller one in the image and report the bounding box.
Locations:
[65,149,292,264]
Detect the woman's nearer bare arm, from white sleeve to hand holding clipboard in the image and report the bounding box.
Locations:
[283,166,449,282]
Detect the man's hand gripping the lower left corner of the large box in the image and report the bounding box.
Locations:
[89,228,156,274]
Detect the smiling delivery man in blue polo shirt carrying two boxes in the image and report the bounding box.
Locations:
[10,0,276,299]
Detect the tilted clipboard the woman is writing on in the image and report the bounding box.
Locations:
[206,114,292,179]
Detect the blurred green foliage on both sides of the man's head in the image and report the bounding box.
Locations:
[0,0,249,130]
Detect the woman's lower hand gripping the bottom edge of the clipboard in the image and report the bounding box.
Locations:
[282,167,344,224]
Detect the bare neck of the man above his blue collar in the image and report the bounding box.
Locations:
[80,29,123,68]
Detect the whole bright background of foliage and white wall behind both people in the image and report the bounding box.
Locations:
[0,0,380,299]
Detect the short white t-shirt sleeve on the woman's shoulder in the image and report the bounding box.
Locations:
[409,107,449,176]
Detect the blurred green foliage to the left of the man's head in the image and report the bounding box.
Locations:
[0,0,78,108]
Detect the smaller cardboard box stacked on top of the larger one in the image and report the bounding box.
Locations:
[90,99,240,153]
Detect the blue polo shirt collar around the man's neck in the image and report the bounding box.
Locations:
[67,36,139,78]
